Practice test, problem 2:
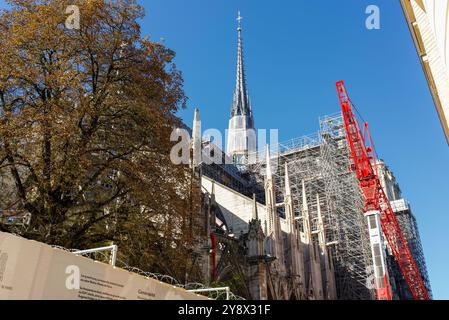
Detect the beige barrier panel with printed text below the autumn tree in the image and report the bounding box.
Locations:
[0,232,207,300]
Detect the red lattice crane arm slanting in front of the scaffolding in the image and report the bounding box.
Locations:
[337,81,430,300]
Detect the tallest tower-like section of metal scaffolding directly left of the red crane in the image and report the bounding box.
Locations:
[320,114,374,299]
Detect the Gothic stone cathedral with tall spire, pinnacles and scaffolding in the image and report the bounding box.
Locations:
[191,13,430,300]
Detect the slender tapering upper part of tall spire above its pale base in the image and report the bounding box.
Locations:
[231,11,252,117]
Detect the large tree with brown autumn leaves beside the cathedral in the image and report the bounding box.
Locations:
[0,0,203,277]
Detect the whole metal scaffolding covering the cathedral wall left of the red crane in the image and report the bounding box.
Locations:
[243,114,373,300]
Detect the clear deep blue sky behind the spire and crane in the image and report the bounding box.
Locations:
[0,0,449,299]
